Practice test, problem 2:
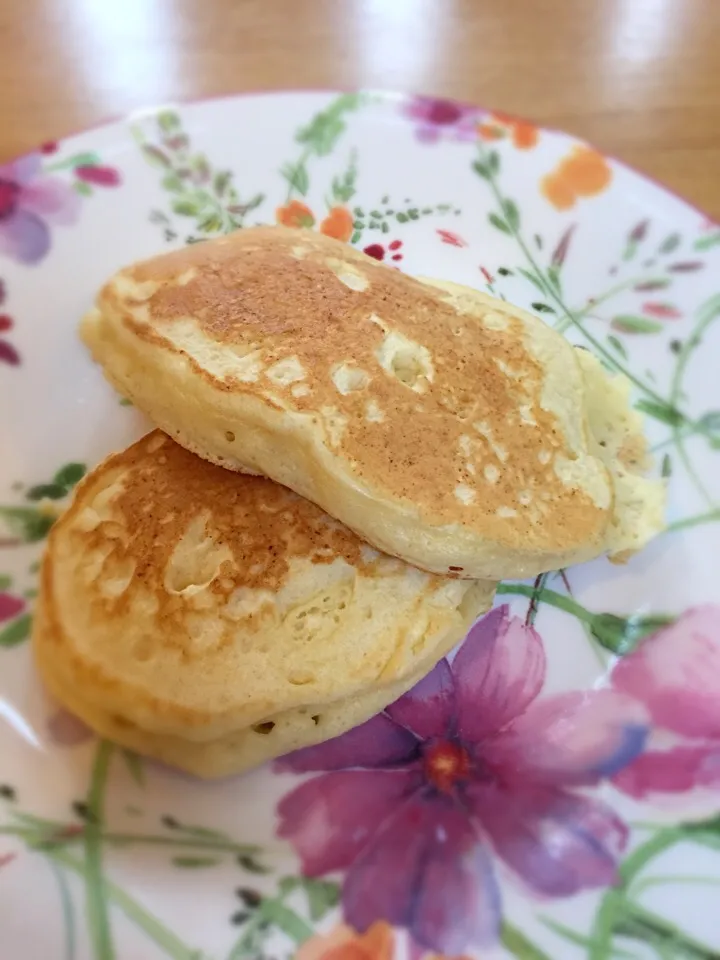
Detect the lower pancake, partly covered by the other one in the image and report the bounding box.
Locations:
[33,431,494,776]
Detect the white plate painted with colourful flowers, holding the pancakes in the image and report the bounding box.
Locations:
[0,92,720,960]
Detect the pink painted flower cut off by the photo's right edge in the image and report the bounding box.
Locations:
[612,604,720,798]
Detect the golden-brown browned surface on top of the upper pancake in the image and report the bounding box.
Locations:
[105,228,609,549]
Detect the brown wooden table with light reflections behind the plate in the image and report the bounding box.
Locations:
[0,0,720,219]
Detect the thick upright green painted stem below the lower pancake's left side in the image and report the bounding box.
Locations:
[84,740,117,960]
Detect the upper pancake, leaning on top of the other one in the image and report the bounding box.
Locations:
[81,227,664,580]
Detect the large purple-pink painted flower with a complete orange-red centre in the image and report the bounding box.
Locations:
[277,606,647,955]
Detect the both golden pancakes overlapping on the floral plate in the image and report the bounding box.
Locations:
[34,228,663,777]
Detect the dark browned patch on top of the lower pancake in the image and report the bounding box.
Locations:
[68,431,370,660]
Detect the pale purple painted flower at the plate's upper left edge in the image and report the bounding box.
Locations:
[0,153,80,264]
